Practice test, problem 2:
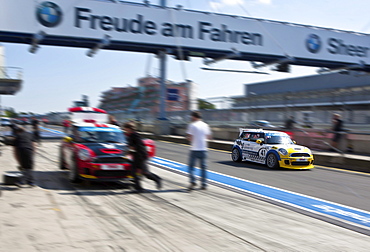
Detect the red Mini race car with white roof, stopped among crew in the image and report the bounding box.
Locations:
[59,107,155,182]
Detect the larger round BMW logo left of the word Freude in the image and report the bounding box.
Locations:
[36,2,63,27]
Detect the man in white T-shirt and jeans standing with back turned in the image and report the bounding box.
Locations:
[186,111,211,190]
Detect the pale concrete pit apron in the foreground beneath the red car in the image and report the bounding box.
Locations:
[0,141,370,251]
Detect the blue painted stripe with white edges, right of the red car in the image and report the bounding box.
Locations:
[151,157,370,227]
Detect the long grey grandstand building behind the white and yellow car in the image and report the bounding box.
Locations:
[232,71,370,126]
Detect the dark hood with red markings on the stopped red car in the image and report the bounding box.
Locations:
[83,143,127,156]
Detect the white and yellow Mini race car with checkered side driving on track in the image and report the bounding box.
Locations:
[231,129,314,170]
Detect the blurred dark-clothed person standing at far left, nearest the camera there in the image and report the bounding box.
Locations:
[13,126,35,186]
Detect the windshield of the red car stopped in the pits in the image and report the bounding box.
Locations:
[77,128,126,143]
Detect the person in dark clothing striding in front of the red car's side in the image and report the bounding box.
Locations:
[123,122,162,192]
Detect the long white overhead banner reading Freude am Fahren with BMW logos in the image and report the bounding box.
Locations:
[0,0,370,65]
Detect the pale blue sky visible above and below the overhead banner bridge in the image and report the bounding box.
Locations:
[1,0,370,113]
